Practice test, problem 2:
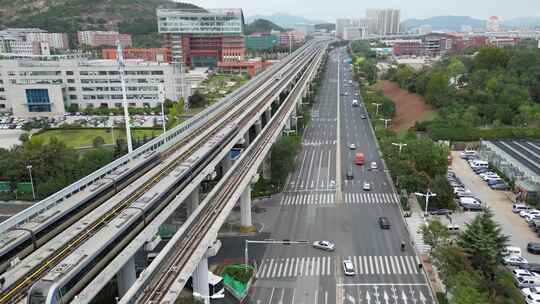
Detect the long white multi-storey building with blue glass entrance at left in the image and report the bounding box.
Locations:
[0,59,187,117]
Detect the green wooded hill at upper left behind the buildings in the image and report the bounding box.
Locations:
[0,0,199,47]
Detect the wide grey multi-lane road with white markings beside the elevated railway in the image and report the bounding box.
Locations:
[249,49,434,304]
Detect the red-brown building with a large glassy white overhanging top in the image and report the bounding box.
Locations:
[157,9,245,68]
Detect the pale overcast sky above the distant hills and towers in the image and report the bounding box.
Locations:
[186,0,540,21]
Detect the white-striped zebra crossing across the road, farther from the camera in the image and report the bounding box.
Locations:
[281,192,399,206]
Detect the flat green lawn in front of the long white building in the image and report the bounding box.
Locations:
[31,129,163,148]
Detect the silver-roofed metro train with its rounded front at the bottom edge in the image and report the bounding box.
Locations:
[27,123,238,304]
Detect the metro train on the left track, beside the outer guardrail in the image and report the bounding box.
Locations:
[0,152,161,273]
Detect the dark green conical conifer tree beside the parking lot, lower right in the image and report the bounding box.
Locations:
[458,209,508,282]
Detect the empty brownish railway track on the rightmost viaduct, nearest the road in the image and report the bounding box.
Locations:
[137,41,326,304]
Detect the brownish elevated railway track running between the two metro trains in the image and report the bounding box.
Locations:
[0,41,316,303]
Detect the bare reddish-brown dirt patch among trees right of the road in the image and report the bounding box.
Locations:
[375,80,437,132]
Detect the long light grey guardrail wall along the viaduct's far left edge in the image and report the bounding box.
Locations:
[0,43,311,234]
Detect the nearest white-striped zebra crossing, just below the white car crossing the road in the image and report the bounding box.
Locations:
[256,256,421,279]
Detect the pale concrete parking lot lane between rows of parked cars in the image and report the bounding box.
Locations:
[451,152,540,263]
